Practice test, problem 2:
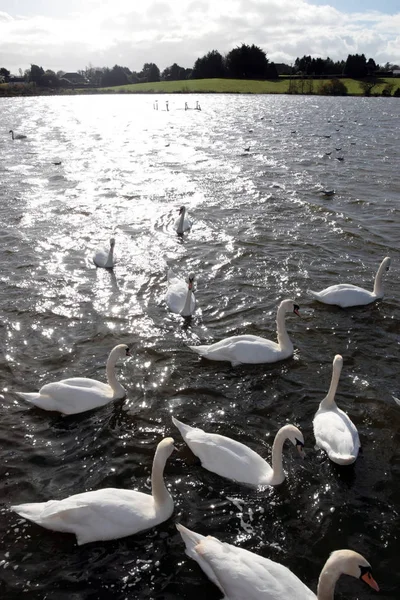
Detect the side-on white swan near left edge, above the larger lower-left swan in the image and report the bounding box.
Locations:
[16,344,131,415]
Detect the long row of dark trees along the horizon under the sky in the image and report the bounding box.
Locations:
[0,44,397,88]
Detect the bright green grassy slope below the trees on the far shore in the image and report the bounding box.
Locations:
[99,77,400,96]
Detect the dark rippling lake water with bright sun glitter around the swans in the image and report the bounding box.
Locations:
[0,95,400,600]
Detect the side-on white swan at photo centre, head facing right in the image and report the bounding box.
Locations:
[189,300,299,366]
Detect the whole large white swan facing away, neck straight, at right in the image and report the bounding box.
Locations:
[313,354,360,465]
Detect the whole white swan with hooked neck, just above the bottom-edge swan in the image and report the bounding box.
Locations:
[172,417,304,486]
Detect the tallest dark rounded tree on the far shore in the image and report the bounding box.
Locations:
[226,44,277,79]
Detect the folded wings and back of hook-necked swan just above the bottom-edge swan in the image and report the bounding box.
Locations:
[185,429,271,485]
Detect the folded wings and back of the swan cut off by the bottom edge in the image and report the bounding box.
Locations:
[195,537,316,600]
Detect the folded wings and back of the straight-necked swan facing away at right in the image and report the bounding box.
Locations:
[314,409,359,456]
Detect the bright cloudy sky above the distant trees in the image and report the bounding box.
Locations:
[0,0,400,74]
